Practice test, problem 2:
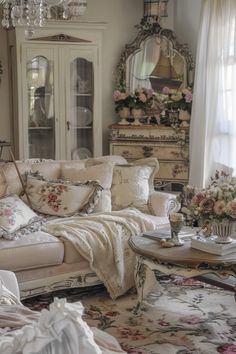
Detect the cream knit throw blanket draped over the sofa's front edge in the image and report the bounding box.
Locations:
[44,209,155,299]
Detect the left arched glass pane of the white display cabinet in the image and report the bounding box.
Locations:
[26,56,55,159]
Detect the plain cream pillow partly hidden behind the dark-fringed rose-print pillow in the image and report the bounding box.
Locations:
[61,162,114,212]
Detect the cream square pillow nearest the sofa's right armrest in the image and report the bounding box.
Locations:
[111,158,159,213]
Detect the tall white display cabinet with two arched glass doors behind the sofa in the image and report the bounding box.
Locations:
[9,21,104,159]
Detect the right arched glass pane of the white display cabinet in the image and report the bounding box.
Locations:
[67,57,95,159]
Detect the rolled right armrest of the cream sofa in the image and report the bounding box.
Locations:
[149,191,180,216]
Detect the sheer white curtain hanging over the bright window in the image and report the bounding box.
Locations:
[189,0,236,187]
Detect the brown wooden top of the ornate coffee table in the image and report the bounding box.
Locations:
[129,235,236,266]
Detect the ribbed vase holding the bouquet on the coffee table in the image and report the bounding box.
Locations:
[212,219,235,243]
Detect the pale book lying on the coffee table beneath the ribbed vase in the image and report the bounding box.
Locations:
[191,235,236,256]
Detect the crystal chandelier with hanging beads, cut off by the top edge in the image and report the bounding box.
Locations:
[0,0,87,35]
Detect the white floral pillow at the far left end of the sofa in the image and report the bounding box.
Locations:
[0,195,40,239]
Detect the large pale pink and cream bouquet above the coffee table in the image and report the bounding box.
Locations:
[178,171,236,221]
